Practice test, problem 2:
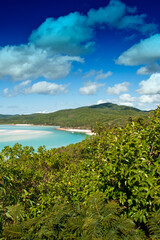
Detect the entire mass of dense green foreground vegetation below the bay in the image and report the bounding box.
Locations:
[0,108,160,240]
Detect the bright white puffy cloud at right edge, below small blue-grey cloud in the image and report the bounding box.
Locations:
[137,73,160,95]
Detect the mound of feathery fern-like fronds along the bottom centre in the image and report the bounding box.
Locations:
[4,194,144,240]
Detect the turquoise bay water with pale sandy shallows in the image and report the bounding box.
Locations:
[0,125,86,150]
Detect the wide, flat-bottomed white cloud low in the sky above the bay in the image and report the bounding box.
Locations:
[24,81,68,95]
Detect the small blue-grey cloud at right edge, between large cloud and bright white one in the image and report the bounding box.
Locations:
[137,63,160,75]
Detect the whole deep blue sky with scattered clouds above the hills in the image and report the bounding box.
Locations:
[0,0,160,114]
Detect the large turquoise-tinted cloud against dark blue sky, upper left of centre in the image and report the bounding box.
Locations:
[29,12,94,55]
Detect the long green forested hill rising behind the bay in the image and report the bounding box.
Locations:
[0,103,149,128]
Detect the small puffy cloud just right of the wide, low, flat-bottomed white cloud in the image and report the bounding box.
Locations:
[79,81,105,95]
